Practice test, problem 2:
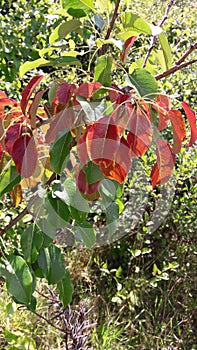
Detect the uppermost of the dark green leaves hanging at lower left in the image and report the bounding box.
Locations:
[21,225,43,263]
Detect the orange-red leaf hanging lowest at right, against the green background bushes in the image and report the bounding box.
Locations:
[151,140,176,188]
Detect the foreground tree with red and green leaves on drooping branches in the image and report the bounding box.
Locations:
[0,0,197,340]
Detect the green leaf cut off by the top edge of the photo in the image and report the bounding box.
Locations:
[61,0,94,18]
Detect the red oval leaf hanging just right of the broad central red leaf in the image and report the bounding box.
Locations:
[126,107,152,157]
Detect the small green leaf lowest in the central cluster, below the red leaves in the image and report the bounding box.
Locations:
[76,222,96,248]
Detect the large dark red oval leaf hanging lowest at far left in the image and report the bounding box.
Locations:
[12,134,38,177]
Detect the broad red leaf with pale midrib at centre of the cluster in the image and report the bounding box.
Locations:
[86,116,120,165]
